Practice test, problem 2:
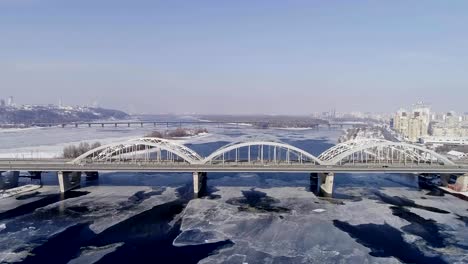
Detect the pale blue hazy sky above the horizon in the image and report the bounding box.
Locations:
[0,0,468,114]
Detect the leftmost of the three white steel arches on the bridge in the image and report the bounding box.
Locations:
[72,137,202,164]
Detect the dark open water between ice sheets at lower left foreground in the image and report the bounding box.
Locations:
[18,194,232,263]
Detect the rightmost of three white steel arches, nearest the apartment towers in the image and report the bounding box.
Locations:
[318,139,454,165]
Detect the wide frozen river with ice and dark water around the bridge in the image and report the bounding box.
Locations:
[0,128,468,264]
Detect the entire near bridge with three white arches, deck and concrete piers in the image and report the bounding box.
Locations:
[0,137,468,194]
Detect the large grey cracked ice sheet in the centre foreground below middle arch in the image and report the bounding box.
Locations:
[174,187,404,263]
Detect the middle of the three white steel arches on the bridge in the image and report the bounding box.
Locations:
[202,141,321,165]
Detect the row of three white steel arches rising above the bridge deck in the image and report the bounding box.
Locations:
[71,137,454,166]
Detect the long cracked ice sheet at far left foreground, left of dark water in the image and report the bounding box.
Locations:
[0,186,178,263]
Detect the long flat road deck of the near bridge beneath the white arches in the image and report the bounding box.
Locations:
[0,159,468,173]
